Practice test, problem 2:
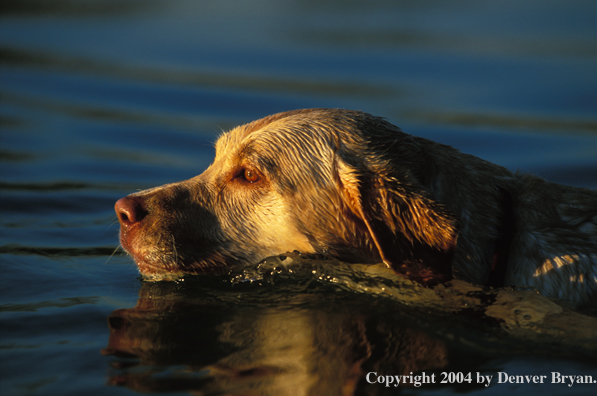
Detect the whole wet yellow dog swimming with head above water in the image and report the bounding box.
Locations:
[115,109,597,305]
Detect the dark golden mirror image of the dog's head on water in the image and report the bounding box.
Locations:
[103,284,447,396]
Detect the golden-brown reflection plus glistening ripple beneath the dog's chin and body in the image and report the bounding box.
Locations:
[103,253,597,395]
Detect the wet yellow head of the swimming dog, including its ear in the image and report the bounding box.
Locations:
[116,109,457,281]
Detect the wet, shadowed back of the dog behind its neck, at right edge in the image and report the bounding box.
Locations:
[505,175,597,304]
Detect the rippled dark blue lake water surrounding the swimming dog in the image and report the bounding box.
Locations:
[0,0,597,396]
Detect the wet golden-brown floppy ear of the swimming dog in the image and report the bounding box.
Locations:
[337,160,458,282]
